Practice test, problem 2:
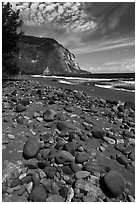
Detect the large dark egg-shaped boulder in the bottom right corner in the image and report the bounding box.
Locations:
[103,170,125,198]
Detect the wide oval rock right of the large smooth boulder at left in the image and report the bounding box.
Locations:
[55,151,74,164]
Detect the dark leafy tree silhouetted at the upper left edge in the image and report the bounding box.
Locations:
[2,2,23,75]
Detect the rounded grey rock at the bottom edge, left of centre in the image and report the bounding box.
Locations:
[29,184,47,202]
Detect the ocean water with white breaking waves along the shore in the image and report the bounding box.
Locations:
[31,73,135,92]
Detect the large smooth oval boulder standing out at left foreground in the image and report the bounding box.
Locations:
[23,138,41,159]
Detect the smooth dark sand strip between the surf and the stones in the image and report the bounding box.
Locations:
[28,76,135,104]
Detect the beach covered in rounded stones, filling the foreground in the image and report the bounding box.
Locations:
[2,77,135,202]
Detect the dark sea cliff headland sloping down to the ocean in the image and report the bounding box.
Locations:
[17,36,87,75]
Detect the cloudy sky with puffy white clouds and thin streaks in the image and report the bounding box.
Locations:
[10,1,135,73]
